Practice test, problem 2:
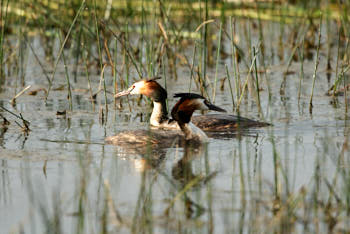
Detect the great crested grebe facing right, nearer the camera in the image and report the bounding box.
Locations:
[105,93,225,146]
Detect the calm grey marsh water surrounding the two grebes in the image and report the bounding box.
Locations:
[0,13,350,233]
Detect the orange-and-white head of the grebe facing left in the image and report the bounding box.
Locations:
[114,77,167,102]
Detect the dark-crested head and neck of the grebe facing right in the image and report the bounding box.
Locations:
[171,93,226,142]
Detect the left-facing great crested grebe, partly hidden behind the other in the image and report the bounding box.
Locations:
[115,77,269,132]
